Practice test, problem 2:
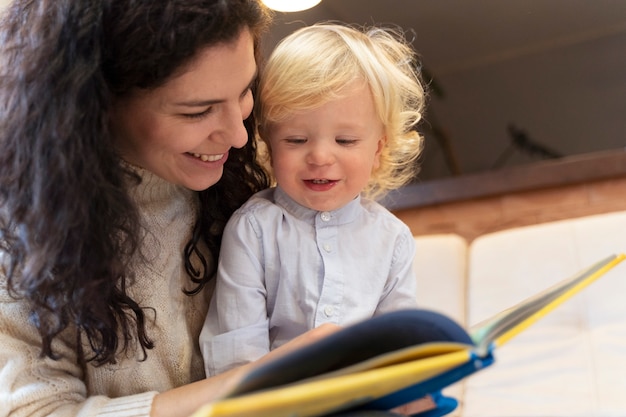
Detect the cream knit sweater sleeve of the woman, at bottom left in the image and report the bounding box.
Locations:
[0,282,157,417]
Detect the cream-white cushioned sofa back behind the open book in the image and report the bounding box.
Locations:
[415,212,626,417]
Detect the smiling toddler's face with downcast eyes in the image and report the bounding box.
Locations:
[268,83,385,211]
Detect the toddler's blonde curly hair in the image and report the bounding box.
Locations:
[255,23,426,199]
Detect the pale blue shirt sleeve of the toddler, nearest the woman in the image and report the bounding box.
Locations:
[200,213,270,376]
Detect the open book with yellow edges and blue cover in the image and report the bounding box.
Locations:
[192,254,626,417]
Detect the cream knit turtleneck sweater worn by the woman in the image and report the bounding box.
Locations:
[0,171,209,417]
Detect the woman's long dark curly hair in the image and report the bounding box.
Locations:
[0,0,271,364]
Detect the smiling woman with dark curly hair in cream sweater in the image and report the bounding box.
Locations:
[0,0,336,417]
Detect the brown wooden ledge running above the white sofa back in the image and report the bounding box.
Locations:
[386,151,626,241]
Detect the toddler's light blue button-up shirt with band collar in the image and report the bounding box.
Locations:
[200,188,416,375]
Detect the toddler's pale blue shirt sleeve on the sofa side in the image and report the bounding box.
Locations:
[375,228,417,315]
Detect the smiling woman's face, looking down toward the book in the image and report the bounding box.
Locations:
[111,29,257,191]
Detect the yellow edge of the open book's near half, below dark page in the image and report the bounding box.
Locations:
[192,348,471,417]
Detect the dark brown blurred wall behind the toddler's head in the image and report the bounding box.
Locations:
[265,0,626,181]
